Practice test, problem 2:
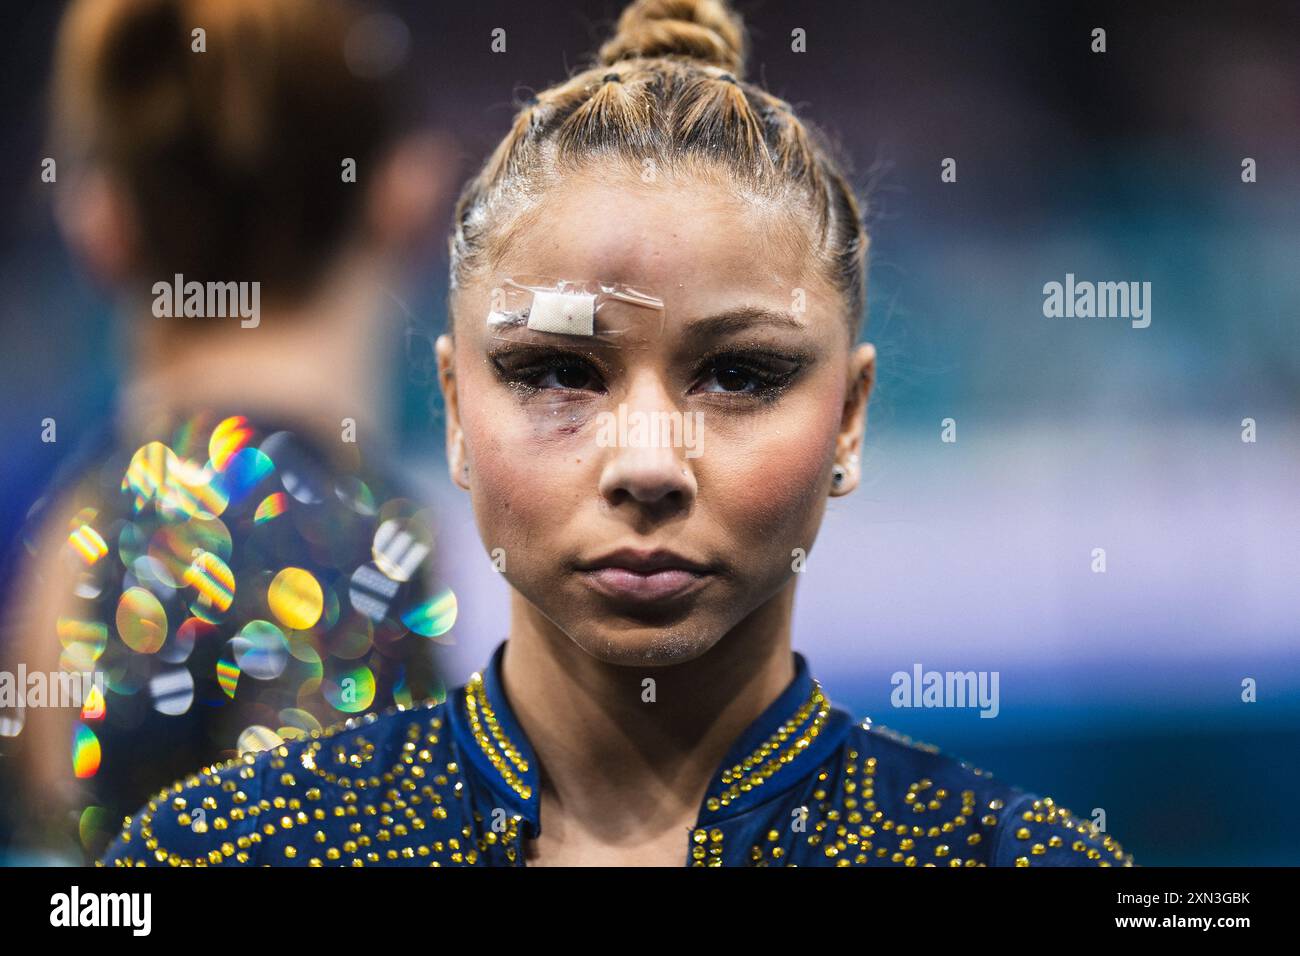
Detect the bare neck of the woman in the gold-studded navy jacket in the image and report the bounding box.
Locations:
[502,581,794,861]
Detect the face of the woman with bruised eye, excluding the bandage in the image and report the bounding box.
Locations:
[438,167,874,665]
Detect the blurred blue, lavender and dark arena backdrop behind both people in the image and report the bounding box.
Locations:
[0,0,1300,865]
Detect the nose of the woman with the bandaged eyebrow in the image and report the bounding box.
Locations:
[599,376,697,510]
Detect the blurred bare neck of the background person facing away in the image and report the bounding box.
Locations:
[118,257,391,455]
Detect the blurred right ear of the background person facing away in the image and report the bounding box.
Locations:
[365,130,458,255]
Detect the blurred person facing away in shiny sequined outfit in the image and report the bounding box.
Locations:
[0,0,455,862]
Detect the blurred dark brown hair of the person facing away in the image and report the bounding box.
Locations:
[52,0,400,304]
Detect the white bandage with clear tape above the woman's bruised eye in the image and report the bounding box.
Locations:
[488,276,663,347]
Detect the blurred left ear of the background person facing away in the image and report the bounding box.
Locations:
[55,169,139,286]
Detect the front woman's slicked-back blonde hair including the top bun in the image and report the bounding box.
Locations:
[450,0,868,338]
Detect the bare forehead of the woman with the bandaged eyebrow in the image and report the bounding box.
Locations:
[497,176,816,315]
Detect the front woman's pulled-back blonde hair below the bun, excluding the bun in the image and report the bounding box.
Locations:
[450,55,867,334]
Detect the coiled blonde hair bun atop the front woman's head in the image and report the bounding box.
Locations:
[598,0,745,78]
